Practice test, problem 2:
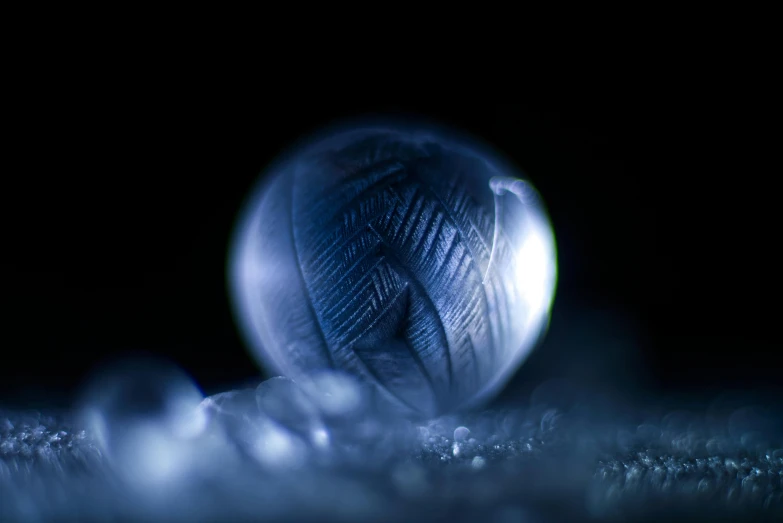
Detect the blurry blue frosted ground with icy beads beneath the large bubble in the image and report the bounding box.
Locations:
[0,374,783,522]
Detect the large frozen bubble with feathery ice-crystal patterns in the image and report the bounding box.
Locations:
[229,118,556,416]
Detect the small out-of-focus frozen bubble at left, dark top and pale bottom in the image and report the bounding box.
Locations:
[79,358,207,487]
